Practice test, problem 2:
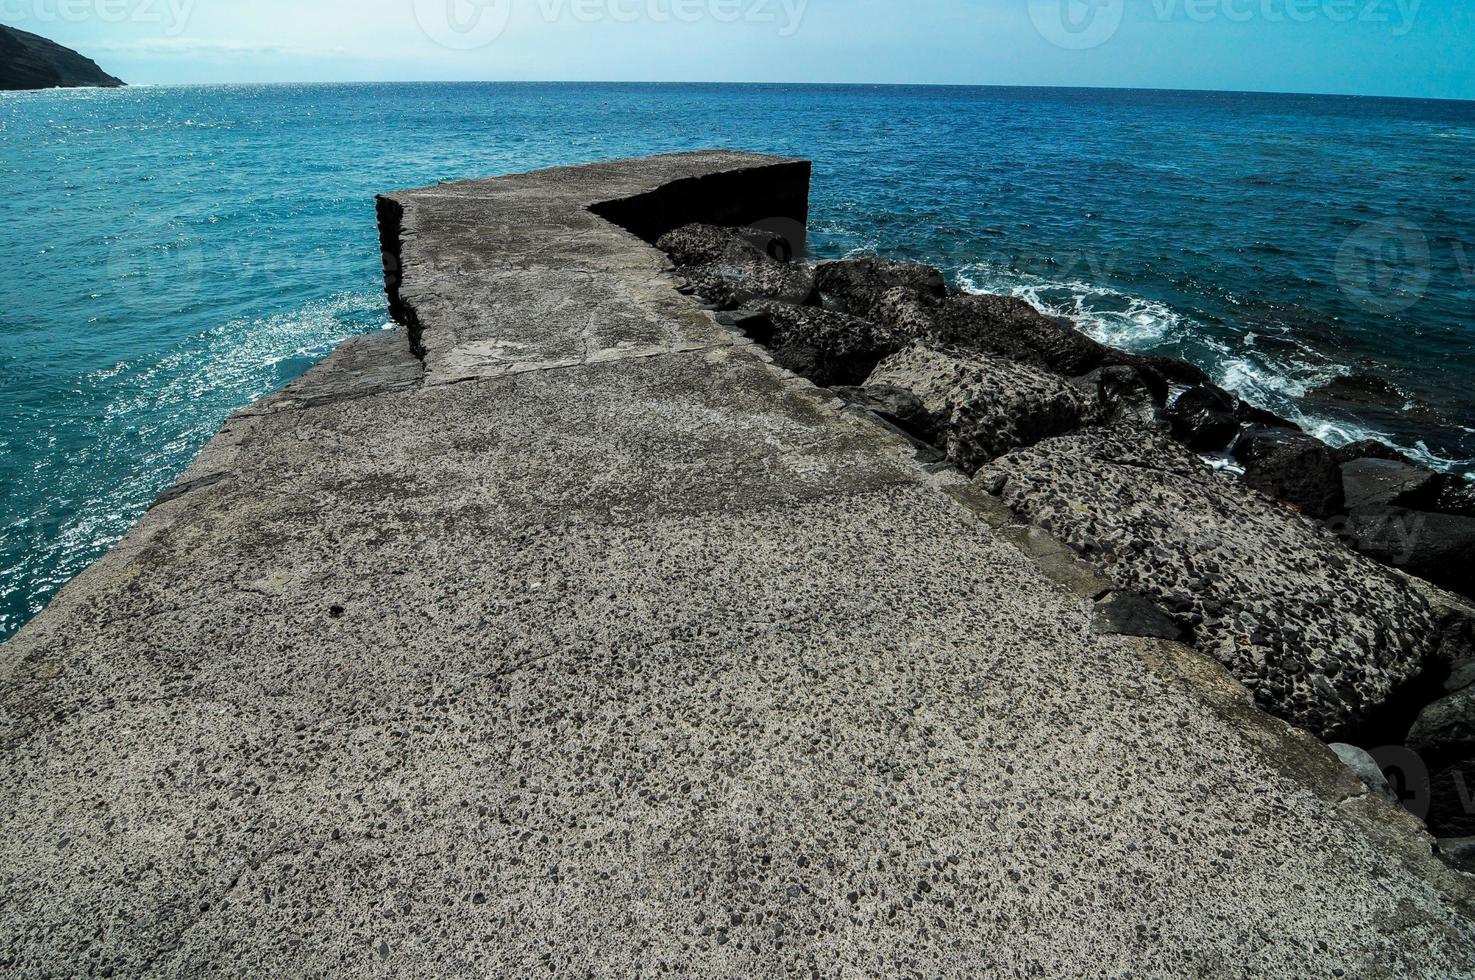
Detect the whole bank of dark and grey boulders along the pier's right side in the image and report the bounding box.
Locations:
[656,224,1475,868]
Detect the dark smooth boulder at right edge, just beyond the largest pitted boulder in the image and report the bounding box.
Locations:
[1328,508,1475,598]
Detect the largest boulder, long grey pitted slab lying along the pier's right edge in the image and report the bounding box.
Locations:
[975,425,1437,736]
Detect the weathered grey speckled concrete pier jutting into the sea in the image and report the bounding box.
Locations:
[0,153,1475,977]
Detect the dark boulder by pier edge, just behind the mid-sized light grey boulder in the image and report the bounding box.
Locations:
[745,300,906,387]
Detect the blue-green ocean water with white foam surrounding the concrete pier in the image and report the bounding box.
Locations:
[0,84,1475,638]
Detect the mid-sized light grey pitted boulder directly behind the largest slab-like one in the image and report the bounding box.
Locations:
[866,347,1097,472]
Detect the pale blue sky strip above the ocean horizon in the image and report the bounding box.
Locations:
[0,0,1475,99]
